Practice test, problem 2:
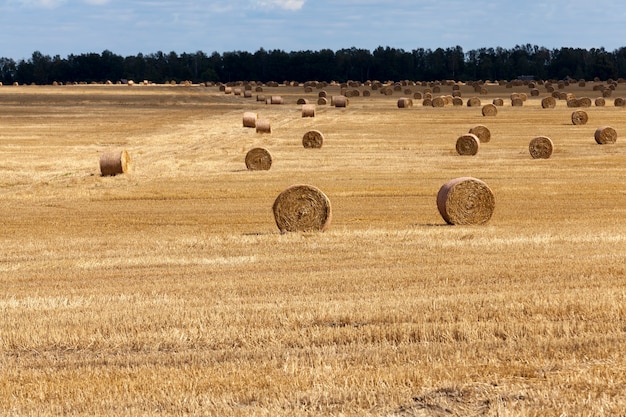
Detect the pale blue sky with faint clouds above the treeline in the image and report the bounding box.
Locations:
[0,0,626,61]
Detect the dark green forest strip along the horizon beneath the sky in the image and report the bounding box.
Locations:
[0,44,626,85]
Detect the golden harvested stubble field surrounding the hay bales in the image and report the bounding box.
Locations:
[0,79,626,416]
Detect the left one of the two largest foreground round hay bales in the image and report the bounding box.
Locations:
[272,185,332,233]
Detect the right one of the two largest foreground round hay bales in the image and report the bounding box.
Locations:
[437,177,495,225]
